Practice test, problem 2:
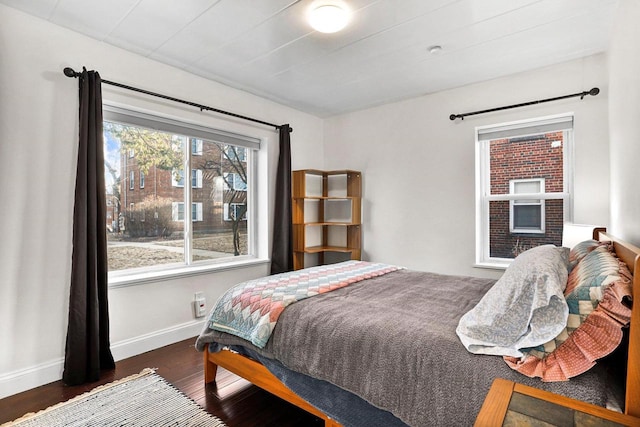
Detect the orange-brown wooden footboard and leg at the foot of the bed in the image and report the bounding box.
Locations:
[204,348,341,427]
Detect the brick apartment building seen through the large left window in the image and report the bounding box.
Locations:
[120,137,247,237]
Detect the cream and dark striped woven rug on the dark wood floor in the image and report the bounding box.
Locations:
[0,369,225,427]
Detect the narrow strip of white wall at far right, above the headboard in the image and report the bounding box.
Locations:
[609,0,640,245]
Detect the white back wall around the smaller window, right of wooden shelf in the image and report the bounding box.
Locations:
[324,55,609,277]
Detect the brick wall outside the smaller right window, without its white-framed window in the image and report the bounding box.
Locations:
[489,132,564,258]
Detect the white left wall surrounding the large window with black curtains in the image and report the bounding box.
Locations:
[0,5,323,398]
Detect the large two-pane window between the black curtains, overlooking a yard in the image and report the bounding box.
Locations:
[104,106,260,282]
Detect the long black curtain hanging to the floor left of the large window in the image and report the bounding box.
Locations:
[62,69,115,385]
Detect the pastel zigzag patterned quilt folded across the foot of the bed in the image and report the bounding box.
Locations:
[209,261,401,348]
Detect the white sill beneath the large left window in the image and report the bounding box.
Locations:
[108,258,270,289]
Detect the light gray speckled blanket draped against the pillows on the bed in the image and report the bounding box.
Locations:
[456,245,569,357]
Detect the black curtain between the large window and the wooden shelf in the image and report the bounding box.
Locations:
[271,124,293,274]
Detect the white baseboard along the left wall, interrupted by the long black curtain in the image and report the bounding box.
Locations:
[0,320,204,399]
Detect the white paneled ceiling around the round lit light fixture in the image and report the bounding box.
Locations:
[0,0,618,117]
